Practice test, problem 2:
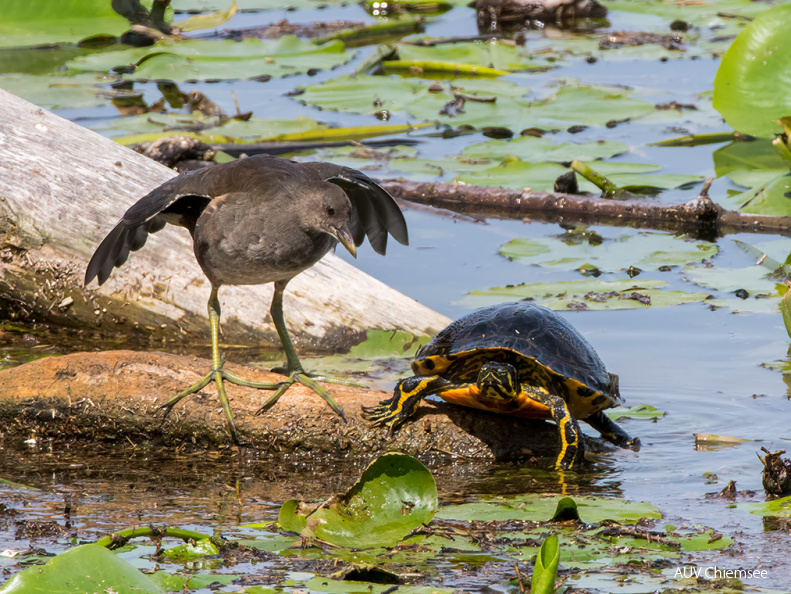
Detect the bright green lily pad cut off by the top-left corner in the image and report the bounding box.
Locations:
[0,0,129,47]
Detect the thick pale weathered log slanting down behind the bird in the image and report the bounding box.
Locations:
[0,90,449,348]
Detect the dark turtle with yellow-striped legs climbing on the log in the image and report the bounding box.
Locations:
[365,303,640,468]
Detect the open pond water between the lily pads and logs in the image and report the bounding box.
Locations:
[0,0,791,590]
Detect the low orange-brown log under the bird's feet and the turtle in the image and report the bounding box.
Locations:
[0,351,612,461]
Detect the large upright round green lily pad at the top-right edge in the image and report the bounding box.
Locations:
[714,4,791,137]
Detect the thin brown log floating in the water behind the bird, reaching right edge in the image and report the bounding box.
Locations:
[381,180,791,237]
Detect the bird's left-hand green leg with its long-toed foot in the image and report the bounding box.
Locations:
[159,286,281,445]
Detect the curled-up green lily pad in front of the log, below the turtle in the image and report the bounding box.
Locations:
[279,453,437,548]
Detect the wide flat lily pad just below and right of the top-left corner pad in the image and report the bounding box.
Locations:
[67,35,352,82]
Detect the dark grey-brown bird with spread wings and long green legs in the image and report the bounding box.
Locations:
[85,155,408,443]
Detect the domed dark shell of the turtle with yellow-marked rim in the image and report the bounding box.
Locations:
[412,303,622,419]
